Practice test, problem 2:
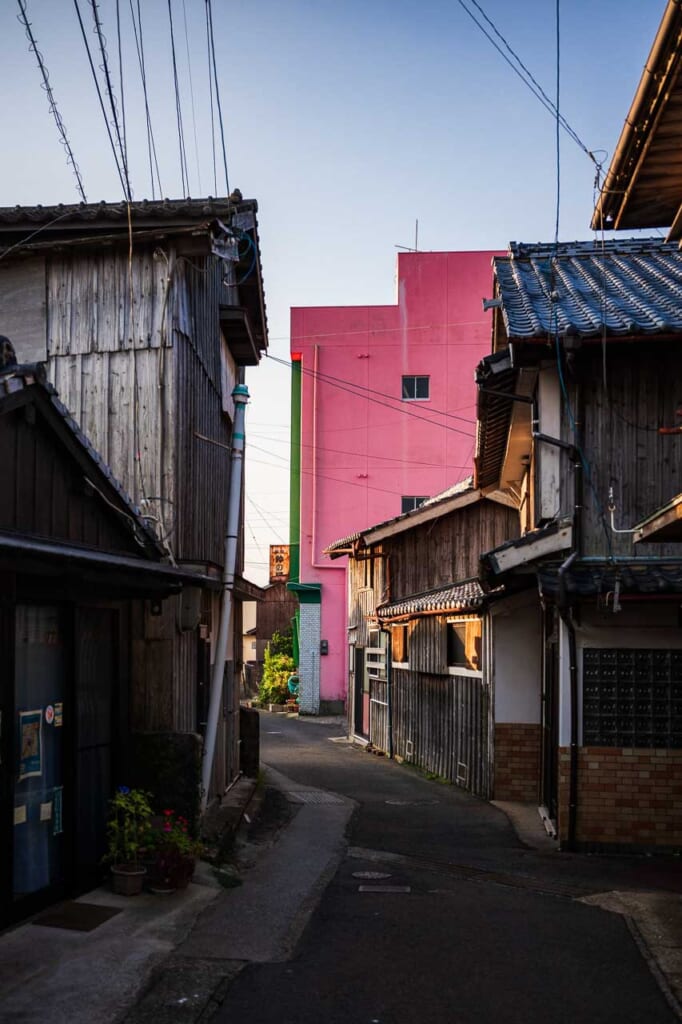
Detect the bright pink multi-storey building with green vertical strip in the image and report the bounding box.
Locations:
[290,252,498,714]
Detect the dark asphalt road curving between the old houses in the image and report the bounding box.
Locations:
[214,716,678,1024]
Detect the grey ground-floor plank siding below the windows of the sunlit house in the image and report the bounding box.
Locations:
[387,669,492,800]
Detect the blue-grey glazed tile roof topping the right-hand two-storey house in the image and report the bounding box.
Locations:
[493,239,682,339]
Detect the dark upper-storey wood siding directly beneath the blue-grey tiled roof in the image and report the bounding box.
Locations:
[562,340,682,557]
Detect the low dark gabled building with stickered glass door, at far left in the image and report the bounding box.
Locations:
[0,367,206,925]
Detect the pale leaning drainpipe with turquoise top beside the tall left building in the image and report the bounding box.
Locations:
[202,384,249,811]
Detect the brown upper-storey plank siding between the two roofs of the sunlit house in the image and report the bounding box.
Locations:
[382,501,519,601]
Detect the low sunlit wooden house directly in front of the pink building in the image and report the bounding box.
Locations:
[328,480,518,798]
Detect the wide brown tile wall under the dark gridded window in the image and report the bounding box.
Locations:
[559,746,682,848]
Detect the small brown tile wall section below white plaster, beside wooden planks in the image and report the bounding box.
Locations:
[494,722,541,803]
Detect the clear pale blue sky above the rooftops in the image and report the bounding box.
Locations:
[0,0,666,584]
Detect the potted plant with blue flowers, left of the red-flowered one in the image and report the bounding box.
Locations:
[104,785,152,896]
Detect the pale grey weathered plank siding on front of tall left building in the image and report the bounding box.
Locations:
[47,250,175,547]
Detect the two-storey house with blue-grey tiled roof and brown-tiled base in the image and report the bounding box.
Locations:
[475,239,682,851]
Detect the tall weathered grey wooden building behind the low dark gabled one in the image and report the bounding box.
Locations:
[0,193,267,795]
